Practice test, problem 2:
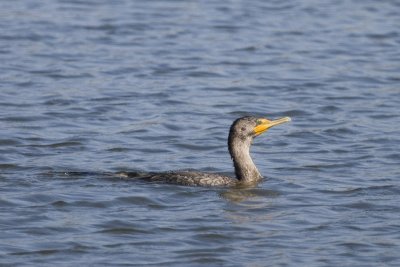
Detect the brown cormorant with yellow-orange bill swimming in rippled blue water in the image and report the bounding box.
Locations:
[119,117,290,186]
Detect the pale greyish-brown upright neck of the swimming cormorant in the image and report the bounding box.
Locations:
[229,138,262,184]
